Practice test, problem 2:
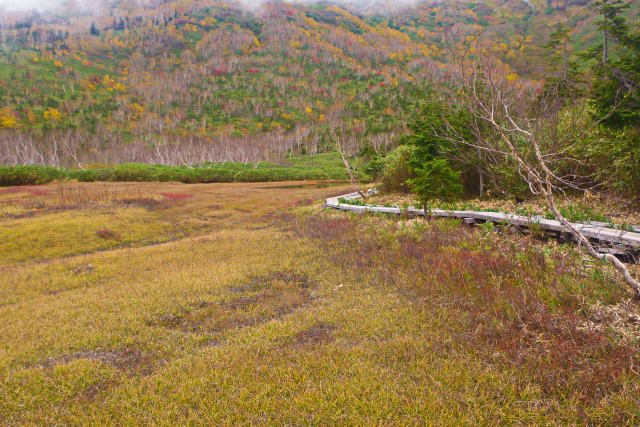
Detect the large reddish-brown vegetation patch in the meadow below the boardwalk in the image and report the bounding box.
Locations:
[288,215,640,408]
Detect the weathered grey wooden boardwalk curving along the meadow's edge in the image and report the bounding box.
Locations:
[325,193,640,255]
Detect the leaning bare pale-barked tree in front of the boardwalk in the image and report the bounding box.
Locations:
[434,35,640,296]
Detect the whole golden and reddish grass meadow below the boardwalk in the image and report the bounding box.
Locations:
[0,182,640,425]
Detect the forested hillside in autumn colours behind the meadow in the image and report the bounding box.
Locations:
[0,0,637,166]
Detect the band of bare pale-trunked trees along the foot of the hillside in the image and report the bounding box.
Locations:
[0,125,330,168]
